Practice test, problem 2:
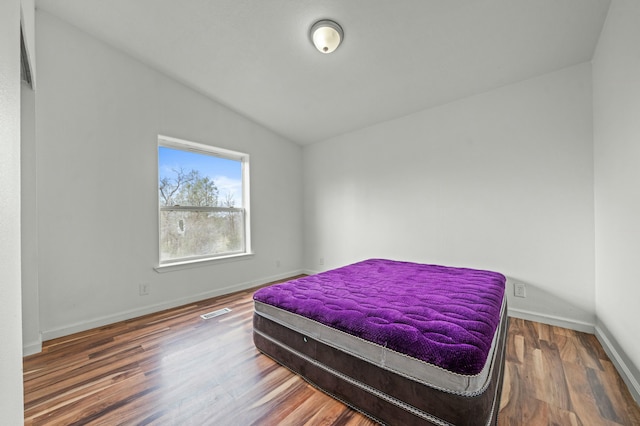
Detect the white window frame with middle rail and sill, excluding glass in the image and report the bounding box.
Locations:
[155,135,253,272]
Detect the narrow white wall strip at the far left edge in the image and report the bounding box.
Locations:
[0,0,23,425]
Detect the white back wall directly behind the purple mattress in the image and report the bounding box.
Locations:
[304,64,595,330]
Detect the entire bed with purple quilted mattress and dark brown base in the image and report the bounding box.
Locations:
[254,259,508,425]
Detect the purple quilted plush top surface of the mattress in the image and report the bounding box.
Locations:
[254,259,506,375]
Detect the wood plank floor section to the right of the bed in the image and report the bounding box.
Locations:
[499,318,640,425]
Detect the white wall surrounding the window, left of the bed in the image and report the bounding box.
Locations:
[36,12,302,340]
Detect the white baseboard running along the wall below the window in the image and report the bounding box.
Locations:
[40,269,304,342]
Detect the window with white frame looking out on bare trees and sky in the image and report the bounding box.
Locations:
[158,136,251,266]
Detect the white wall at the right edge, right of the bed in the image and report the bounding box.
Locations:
[593,0,640,401]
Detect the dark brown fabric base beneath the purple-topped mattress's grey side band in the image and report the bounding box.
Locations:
[253,306,507,426]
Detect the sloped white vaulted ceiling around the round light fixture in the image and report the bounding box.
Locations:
[36,0,610,144]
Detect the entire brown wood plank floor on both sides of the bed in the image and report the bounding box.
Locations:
[24,280,640,426]
